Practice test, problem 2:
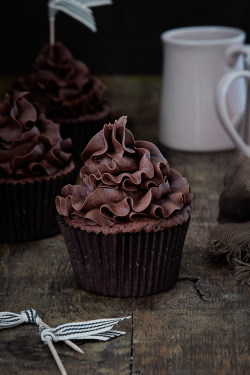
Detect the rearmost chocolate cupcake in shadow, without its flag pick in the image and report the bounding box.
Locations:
[13,43,109,168]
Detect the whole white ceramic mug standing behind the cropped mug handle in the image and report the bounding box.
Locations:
[160,26,250,152]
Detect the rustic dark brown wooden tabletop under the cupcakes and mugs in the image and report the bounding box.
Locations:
[0,76,250,375]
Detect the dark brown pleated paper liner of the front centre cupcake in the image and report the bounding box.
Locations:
[57,215,189,297]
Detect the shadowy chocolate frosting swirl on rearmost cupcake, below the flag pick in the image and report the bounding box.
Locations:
[13,43,106,120]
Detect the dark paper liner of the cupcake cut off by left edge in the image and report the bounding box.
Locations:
[0,165,76,242]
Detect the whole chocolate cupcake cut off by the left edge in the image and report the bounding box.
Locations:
[0,92,76,242]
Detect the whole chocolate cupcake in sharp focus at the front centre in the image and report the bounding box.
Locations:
[56,116,192,297]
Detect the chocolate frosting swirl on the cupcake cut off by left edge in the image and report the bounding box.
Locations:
[0,92,72,179]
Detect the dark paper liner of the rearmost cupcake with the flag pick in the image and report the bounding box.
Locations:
[58,109,110,169]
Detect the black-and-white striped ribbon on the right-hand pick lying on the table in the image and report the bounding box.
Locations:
[39,316,130,342]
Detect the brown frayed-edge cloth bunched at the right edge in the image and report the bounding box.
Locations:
[203,155,250,285]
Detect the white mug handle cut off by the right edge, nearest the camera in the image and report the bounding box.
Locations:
[215,70,250,157]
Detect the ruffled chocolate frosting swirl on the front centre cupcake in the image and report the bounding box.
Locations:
[56,116,192,226]
